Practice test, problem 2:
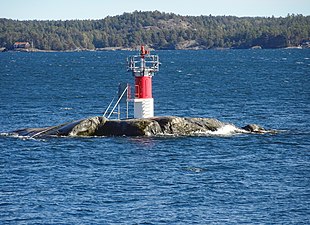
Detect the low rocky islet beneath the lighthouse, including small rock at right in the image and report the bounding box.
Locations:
[13,116,265,137]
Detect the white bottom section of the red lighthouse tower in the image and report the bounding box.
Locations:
[133,98,154,119]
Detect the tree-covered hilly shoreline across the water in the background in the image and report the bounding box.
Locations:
[0,11,310,51]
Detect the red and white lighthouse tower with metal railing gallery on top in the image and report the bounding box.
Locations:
[127,45,159,118]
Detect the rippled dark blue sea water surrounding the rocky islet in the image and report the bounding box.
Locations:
[0,49,310,224]
